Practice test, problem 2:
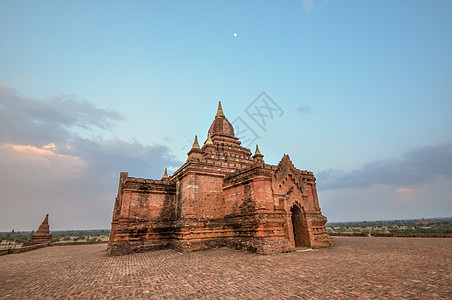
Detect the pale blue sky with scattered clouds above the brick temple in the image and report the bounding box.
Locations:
[0,0,452,230]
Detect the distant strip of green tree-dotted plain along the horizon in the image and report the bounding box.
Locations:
[0,217,452,249]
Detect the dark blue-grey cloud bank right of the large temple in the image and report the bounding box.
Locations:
[318,143,452,190]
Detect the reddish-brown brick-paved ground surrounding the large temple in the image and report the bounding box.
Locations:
[0,237,452,299]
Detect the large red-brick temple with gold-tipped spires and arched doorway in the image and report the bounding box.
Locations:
[108,103,333,255]
